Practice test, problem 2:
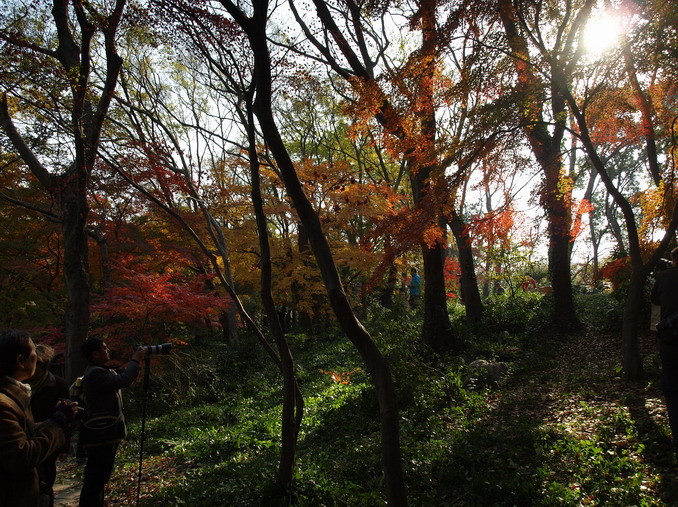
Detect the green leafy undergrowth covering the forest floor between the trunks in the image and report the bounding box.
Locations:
[110,295,678,507]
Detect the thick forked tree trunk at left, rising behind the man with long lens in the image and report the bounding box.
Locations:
[0,0,126,381]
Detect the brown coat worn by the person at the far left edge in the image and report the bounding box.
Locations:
[0,377,66,507]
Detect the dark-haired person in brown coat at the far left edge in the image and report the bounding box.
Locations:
[0,329,77,507]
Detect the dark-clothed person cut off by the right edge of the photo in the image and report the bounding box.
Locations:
[650,248,678,457]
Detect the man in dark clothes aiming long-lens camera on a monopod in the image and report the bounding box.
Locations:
[80,338,145,507]
